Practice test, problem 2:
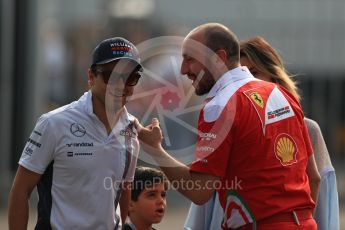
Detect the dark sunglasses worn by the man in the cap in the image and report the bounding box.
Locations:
[94,68,142,86]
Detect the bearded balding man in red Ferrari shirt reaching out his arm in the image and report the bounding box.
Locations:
[138,23,320,229]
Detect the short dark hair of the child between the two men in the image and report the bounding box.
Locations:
[131,167,169,201]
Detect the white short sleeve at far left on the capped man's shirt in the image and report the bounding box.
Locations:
[19,116,56,174]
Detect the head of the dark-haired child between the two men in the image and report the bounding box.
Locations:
[129,167,169,225]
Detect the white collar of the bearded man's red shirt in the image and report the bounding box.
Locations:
[206,66,254,98]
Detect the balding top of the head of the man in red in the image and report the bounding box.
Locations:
[186,23,240,65]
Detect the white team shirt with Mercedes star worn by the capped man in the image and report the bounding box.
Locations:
[19,91,139,229]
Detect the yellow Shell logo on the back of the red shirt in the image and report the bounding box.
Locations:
[274,133,298,166]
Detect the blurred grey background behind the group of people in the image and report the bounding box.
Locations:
[0,0,345,229]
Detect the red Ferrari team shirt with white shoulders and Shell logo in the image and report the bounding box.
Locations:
[191,67,314,228]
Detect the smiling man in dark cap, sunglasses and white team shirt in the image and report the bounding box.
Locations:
[9,37,142,229]
